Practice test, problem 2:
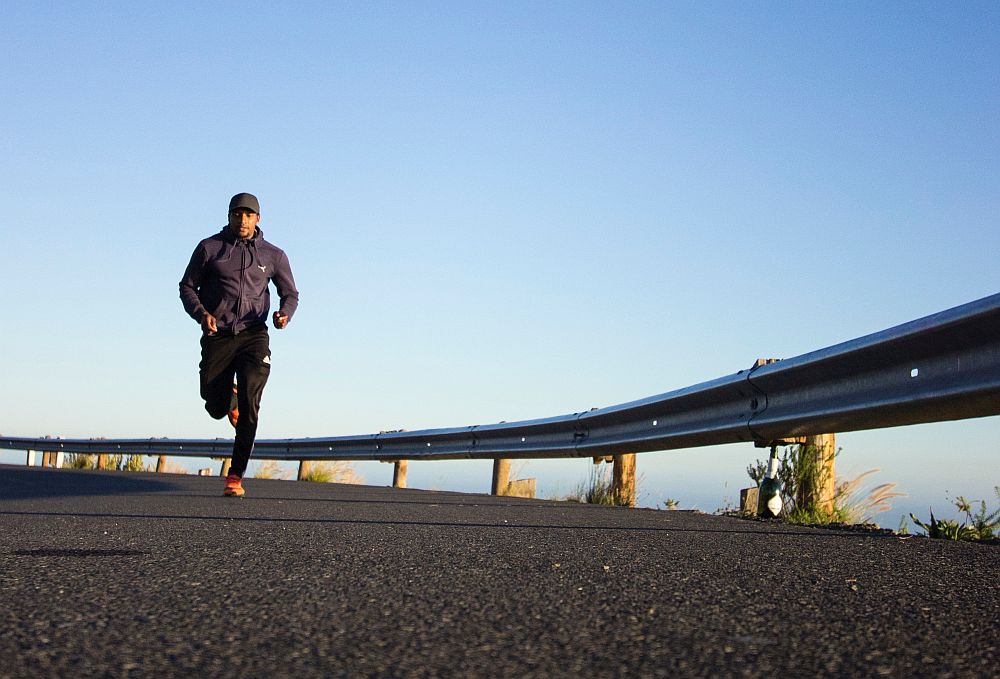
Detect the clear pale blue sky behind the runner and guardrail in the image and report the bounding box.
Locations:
[0,2,1000,524]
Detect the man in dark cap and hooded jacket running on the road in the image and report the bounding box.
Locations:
[180,193,299,497]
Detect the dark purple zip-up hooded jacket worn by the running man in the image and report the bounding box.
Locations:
[180,227,299,335]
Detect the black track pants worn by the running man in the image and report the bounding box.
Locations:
[198,325,271,476]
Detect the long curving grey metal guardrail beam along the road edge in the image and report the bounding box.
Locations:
[0,294,1000,461]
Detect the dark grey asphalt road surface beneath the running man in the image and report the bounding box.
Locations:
[0,466,1000,677]
